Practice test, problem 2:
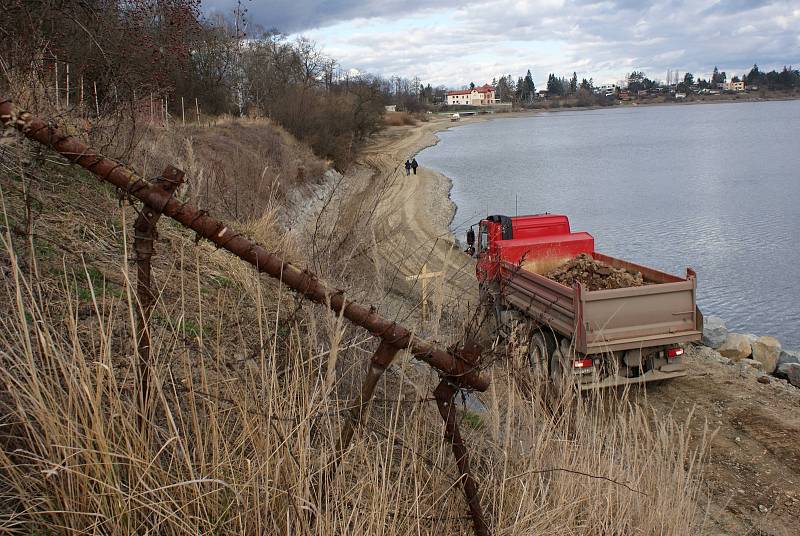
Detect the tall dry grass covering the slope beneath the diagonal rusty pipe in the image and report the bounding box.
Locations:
[0,120,702,535]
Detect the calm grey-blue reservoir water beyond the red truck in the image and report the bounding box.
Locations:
[417,100,800,349]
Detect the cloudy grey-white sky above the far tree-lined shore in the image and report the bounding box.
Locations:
[204,0,800,87]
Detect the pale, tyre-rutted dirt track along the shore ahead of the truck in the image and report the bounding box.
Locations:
[318,118,477,322]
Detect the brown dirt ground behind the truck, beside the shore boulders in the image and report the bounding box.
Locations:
[641,347,800,536]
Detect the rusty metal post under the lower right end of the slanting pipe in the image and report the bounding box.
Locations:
[433,380,491,536]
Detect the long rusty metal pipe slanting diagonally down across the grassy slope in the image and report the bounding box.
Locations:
[0,99,489,391]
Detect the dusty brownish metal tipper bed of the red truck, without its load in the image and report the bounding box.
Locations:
[500,252,702,354]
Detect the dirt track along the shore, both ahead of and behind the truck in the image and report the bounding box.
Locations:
[326,116,800,536]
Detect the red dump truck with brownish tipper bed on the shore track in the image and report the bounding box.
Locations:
[467,214,703,390]
